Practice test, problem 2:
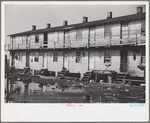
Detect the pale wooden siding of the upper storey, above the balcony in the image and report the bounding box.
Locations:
[11,20,145,49]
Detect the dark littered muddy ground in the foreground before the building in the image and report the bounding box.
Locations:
[4,80,145,103]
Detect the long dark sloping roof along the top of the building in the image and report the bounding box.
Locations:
[8,13,145,36]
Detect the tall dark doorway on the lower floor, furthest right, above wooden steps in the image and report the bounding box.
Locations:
[120,50,128,72]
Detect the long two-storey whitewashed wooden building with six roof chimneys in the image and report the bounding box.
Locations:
[8,7,146,77]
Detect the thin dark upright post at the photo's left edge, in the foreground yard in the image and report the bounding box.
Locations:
[5,55,9,103]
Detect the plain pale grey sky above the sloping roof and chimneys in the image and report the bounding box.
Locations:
[5,4,145,43]
